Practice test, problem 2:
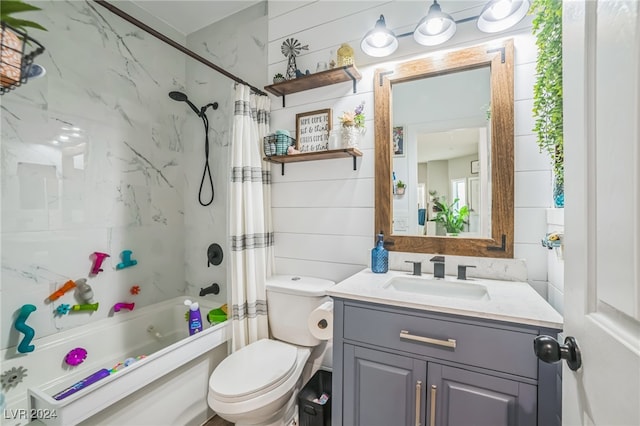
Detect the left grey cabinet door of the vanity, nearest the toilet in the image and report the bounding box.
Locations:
[343,344,427,426]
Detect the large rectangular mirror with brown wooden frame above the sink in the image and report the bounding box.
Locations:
[374,40,514,258]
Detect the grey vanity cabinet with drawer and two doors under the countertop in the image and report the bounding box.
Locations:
[332,298,561,426]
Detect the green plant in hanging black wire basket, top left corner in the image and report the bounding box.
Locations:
[0,0,46,93]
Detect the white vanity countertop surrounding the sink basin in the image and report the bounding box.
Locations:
[328,269,563,330]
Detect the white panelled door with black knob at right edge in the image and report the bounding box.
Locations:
[562,0,640,426]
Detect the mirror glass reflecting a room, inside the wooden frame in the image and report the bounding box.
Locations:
[392,66,491,238]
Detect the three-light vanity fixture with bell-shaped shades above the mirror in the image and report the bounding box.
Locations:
[360,0,531,58]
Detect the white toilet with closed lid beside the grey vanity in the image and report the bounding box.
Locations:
[207,275,335,426]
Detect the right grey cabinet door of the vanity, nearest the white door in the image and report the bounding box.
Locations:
[425,363,537,426]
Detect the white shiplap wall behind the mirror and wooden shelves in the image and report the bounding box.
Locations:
[267,0,551,296]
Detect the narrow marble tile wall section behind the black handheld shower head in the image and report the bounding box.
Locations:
[184,2,267,310]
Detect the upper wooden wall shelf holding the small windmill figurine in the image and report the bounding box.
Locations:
[264,65,362,108]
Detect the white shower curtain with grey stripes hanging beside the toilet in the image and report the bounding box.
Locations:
[229,84,274,351]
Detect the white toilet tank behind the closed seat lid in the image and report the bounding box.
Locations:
[267,275,335,346]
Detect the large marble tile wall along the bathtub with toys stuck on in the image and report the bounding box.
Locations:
[0,1,190,350]
